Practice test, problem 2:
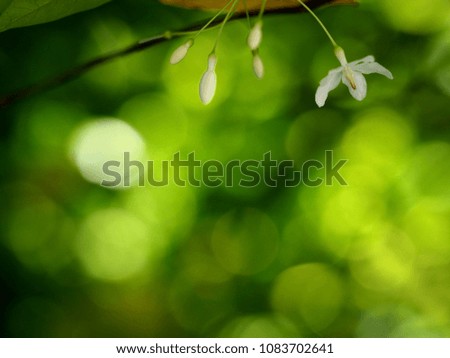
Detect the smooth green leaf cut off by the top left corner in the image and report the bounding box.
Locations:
[0,0,110,32]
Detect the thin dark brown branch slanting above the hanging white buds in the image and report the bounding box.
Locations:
[0,0,356,108]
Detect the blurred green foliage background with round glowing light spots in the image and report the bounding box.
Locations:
[0,0,450,337]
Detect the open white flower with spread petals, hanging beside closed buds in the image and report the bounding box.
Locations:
[316,47,394,107]
